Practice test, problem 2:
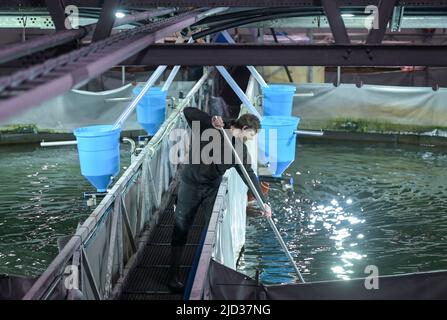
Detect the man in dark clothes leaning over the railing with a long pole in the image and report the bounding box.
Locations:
[168,108,271,293]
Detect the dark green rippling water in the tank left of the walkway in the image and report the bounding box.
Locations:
[0,145,130,276]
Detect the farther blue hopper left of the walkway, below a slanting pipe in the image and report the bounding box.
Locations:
[133,87,167,136]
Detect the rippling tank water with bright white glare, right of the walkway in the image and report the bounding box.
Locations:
[239,145,447,284]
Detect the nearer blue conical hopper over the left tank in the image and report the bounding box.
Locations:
[74,125,121,192]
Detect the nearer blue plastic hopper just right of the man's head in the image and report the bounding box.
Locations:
[258,116,300,177]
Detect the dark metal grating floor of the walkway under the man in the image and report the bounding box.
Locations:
[119,198,205,300]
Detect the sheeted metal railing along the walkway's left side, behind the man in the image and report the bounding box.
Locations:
[24,73,212,300]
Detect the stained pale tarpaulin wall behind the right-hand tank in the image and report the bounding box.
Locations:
[293,83,447,129]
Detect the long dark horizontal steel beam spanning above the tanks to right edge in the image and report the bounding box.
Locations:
[123,44,447,67]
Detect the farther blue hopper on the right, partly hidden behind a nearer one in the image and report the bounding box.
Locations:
[262,84,296,116]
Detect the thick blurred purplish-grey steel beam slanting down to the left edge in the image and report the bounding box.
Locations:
[0,10,203,120]
